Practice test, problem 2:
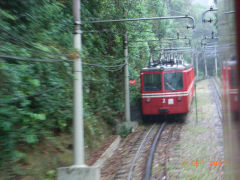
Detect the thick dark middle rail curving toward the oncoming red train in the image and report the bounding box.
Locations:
[145,121,167,180]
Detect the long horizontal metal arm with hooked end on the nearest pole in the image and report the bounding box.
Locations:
[82,15,196,29]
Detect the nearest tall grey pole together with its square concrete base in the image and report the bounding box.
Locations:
[57,0,100,180]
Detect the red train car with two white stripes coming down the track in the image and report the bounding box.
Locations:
[141,60,194,117]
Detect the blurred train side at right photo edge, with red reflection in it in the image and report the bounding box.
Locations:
[217,0,240,179]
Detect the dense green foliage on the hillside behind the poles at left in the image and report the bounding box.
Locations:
[0,0,206,178]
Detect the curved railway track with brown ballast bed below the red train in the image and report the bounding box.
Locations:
[101,122,178,180]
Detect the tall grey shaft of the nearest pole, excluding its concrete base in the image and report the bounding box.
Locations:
[73,0,84,166]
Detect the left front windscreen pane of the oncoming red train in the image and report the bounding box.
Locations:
[144,74,162,91]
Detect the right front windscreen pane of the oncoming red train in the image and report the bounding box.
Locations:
[164,72,183,91]
